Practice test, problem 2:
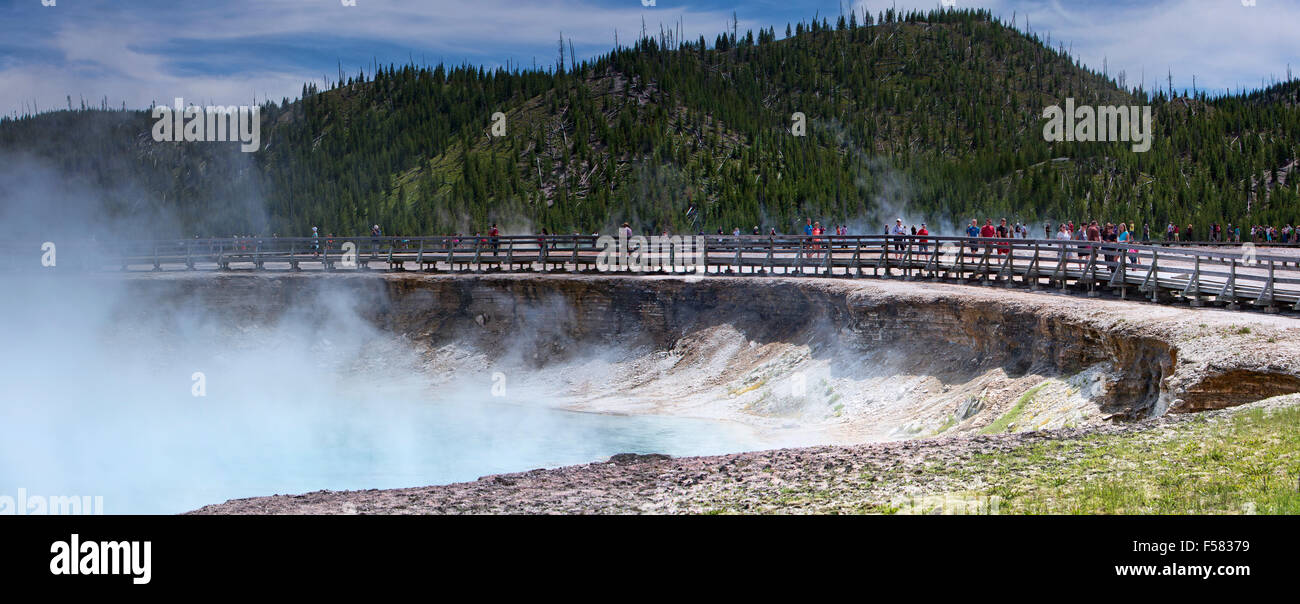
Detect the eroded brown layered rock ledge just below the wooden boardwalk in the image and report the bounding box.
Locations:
[131,273,1300,420]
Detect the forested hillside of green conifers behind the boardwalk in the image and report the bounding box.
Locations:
[0,10,1300,236]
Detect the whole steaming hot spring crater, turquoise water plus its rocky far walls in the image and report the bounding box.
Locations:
[0,273,1294,513]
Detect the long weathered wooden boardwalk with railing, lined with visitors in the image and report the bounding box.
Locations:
[5,235,1300,312]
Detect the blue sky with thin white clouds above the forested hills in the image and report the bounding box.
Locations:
[0,0,1300,114]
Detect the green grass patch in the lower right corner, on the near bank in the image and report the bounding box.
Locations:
[967,408,1300,514]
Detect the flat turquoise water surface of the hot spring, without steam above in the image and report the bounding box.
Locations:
[0,377,764,514]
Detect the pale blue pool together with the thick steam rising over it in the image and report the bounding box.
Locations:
[0,278,767,513]
